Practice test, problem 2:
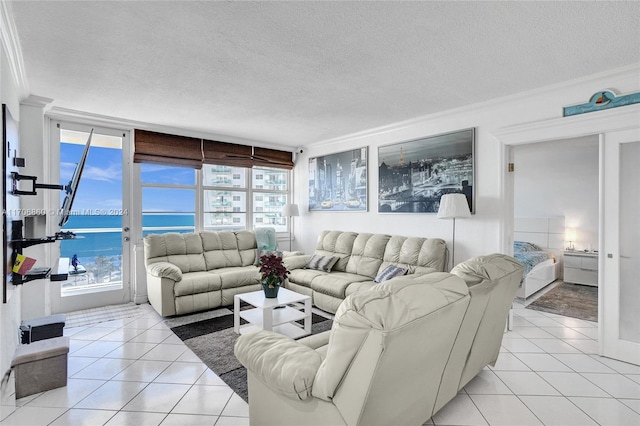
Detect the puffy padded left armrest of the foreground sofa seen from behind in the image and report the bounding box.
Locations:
[234,331,322,400]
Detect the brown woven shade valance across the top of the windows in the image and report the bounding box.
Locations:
[133,129,293,170]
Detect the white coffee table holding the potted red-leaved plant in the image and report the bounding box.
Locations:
[233,287,311,339]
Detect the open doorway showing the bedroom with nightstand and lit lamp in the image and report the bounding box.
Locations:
[512,135,599,321]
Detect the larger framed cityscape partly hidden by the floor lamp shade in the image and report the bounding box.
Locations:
[378,128,475,213]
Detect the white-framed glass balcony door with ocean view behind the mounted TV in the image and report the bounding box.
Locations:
[48,121,132,313]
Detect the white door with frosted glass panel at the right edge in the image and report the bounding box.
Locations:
[599,129,640,365]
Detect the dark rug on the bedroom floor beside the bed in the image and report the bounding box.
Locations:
[527,282,598,322]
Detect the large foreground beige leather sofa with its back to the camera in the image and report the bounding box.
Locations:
[235,255,523,425]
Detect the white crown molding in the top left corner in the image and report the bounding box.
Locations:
[0,0,29,98]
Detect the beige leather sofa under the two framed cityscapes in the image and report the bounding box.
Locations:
[284,231,447,313]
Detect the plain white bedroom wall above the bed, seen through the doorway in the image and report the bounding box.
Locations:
[513,135,599,250]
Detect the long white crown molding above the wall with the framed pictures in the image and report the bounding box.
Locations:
[306,64,640,148]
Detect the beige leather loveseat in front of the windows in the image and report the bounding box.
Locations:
[144,231,262,316]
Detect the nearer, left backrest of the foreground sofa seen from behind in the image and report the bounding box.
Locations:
[312,272,469,425]
